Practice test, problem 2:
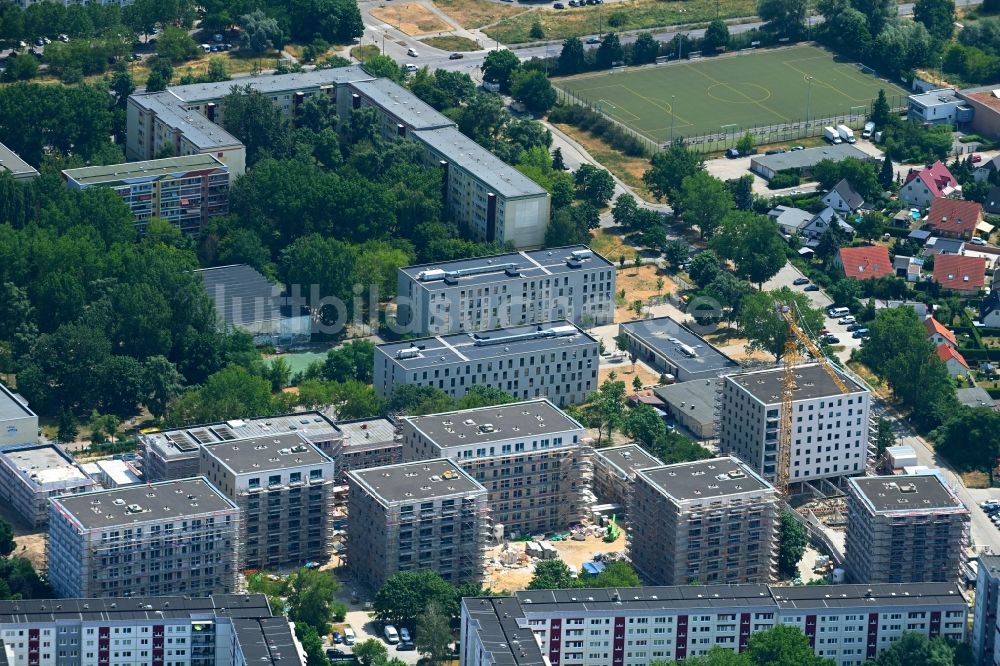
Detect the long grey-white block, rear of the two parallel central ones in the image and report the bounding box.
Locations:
[396,245,615,335]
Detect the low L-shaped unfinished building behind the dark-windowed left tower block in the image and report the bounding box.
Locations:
[139,412,344,481]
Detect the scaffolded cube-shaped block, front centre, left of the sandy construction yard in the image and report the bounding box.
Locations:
[347,459,490,590]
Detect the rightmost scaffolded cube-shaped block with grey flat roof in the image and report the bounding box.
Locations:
[845,474,970,584]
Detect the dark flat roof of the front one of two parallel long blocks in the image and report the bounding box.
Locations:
[377,320,597,370]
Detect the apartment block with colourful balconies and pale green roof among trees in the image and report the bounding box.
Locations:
[62,154,229,234]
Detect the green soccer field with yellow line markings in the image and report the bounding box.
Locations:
[555,46,907,143]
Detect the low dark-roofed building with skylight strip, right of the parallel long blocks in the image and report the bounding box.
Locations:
[618,317,740,382]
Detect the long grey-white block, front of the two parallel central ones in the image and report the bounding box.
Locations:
[375,321,600,406]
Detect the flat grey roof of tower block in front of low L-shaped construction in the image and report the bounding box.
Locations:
[203,433,331,474]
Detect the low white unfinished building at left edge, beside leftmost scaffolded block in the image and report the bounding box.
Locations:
[0,444,97,528]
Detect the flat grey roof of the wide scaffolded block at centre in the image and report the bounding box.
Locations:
[403,400,583,448]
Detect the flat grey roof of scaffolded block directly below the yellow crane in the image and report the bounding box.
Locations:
[637,456,774,502]
